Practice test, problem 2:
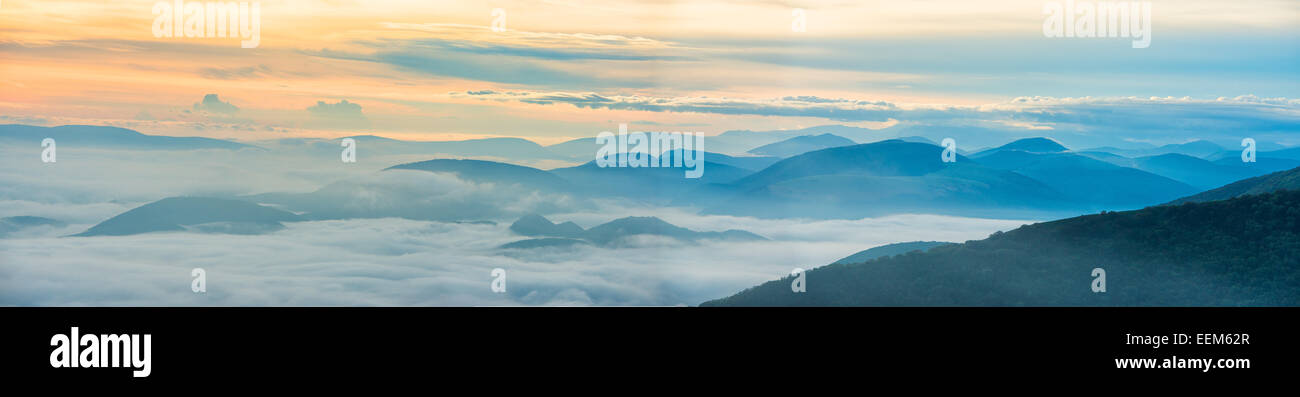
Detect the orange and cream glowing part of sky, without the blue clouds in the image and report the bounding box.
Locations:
[0,0,1297,143]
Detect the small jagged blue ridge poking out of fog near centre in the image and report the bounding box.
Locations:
[502,215,767,249]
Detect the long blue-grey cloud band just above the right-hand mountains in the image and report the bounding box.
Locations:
[450,90,1300,146]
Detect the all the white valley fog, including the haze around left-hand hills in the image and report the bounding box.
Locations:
[0,139,1023,306]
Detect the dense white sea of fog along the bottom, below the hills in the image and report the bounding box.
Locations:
[0,208,1019,306]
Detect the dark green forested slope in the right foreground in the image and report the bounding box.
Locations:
[703,190,1300,306]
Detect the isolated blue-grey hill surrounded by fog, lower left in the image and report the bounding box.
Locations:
[74,197,302,237]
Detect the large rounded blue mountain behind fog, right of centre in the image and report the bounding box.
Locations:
[677,139,1075,219]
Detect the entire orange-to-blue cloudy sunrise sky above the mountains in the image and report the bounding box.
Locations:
[0,0,1300,147]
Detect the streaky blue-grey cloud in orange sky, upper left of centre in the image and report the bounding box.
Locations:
[303,22,688,89]
